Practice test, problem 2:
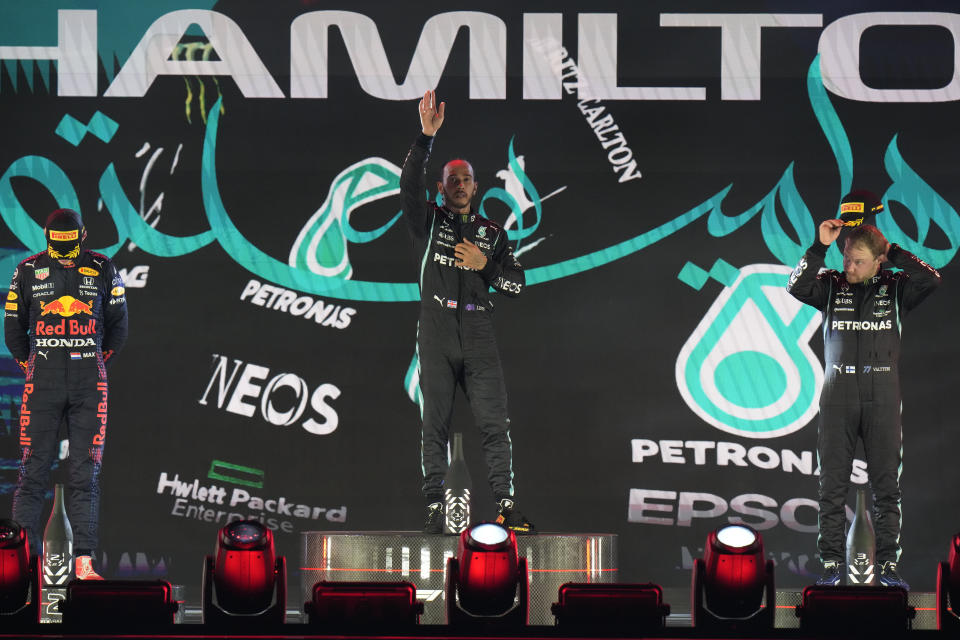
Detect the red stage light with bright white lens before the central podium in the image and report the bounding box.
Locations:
[446,522,528,625]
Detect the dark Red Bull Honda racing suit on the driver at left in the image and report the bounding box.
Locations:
[4,251,127,553]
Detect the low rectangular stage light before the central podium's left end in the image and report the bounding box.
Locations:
[303,581,423,631]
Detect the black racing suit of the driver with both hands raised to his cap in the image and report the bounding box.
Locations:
[787,242,940,564]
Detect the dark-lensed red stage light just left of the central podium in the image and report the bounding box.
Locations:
[203,520,287,623]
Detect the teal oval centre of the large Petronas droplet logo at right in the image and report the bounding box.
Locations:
[713,351,787,409]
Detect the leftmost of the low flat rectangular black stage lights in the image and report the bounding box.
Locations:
[60,580,178,631]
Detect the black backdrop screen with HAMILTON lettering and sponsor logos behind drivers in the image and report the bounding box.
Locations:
[0,0,960,590]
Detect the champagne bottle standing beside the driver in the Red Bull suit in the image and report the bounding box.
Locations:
[40,484,73,622]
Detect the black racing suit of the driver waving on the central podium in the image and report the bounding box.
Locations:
[400,134,526,502]
